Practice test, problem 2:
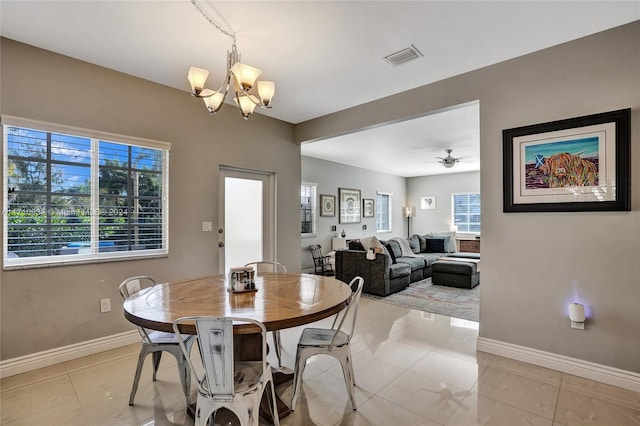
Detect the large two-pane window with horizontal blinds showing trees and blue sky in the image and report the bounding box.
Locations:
[2,116,169,269]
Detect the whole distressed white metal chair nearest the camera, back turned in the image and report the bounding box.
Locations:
[173,316,280,426]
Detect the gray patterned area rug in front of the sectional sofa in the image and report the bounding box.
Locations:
[362,278,480,322]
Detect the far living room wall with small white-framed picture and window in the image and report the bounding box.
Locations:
[407,172,480,234]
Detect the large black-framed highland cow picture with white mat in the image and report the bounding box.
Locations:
[502,108,631,213]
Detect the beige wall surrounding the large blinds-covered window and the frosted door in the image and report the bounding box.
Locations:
[0,39,300,360]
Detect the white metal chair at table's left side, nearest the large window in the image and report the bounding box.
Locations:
[120,275,196,406]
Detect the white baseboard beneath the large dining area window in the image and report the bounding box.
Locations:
[0,330,140,378]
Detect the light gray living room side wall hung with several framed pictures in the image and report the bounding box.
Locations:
[301,156,406,270]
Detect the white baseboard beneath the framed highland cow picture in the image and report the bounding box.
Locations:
[476,337,640,392]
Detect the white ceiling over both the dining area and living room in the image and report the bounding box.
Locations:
[0,0,640,176]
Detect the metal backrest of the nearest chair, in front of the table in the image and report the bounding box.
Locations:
[173,316,267,400]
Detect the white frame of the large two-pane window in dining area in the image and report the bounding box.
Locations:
[1,114,171,270]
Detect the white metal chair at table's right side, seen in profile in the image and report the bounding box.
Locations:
[291,277,364,411]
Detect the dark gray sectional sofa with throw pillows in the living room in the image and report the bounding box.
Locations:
[335,234,479,296]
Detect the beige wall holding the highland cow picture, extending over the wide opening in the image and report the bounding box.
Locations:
[295,21,640,372]
